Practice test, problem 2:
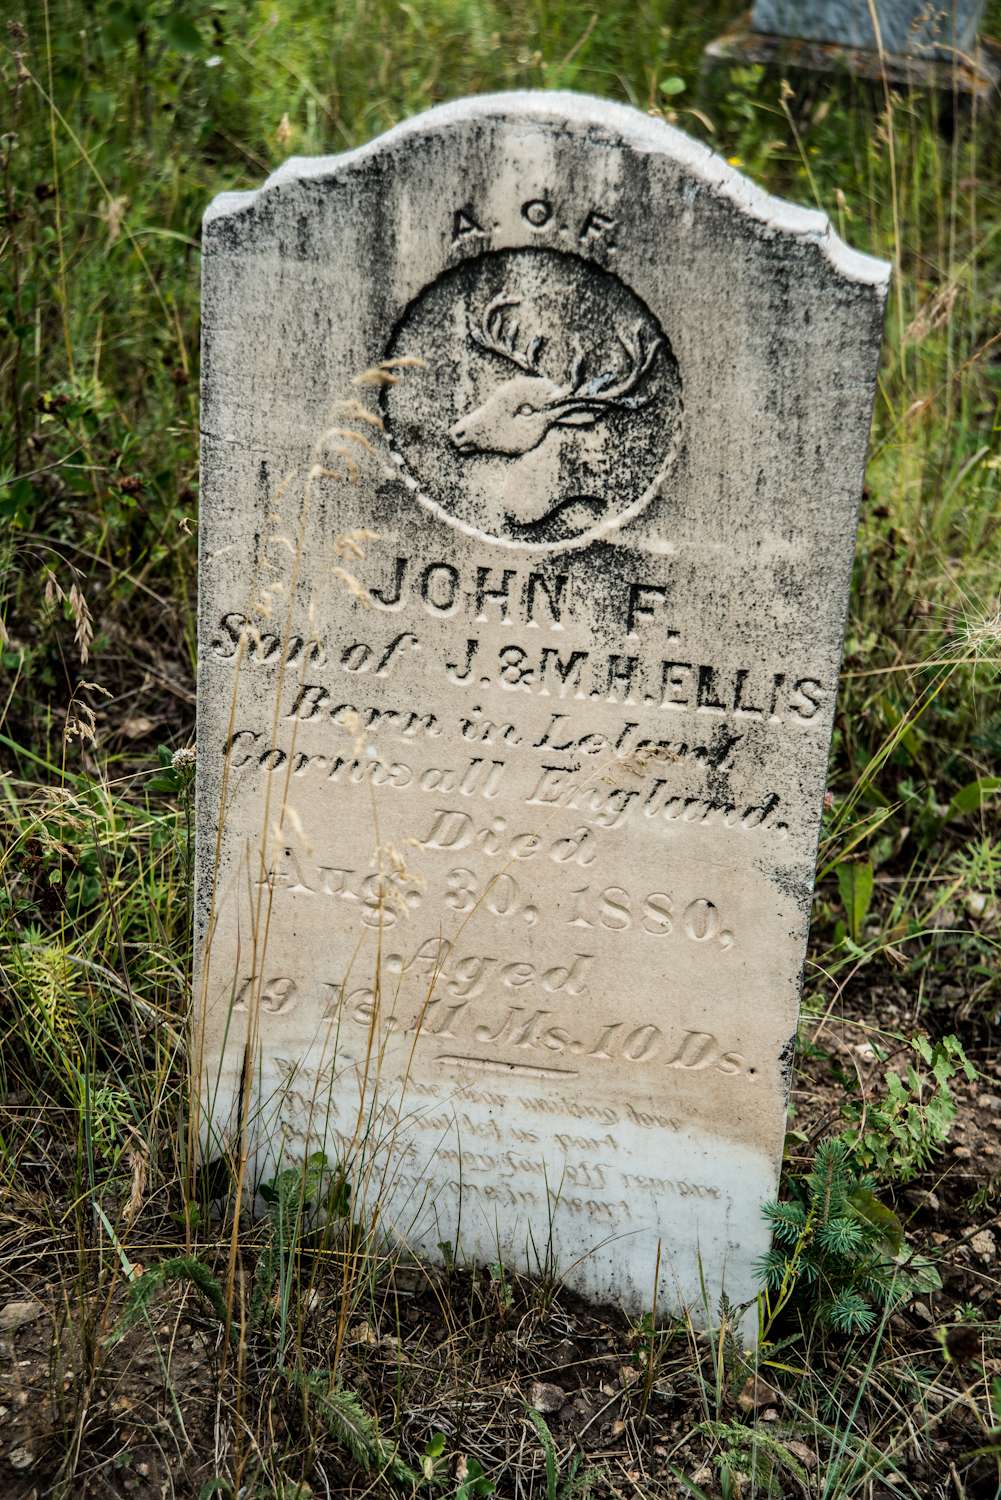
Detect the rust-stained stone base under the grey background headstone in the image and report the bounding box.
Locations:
[702,14,1001,104]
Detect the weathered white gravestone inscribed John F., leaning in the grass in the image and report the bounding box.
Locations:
[194,93,888,1319]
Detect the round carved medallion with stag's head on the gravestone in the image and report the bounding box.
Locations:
[383,249,681,552]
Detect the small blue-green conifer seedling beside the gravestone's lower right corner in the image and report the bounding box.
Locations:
[756,1137,938,1338]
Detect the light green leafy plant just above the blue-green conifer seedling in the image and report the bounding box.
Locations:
[842,1037,977,1182]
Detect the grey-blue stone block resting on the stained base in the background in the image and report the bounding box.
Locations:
[752,0,984,59]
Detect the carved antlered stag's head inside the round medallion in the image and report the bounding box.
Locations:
[449,293,663,455]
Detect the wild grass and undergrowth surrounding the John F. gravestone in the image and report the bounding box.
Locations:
[0,0,1001,1500]
